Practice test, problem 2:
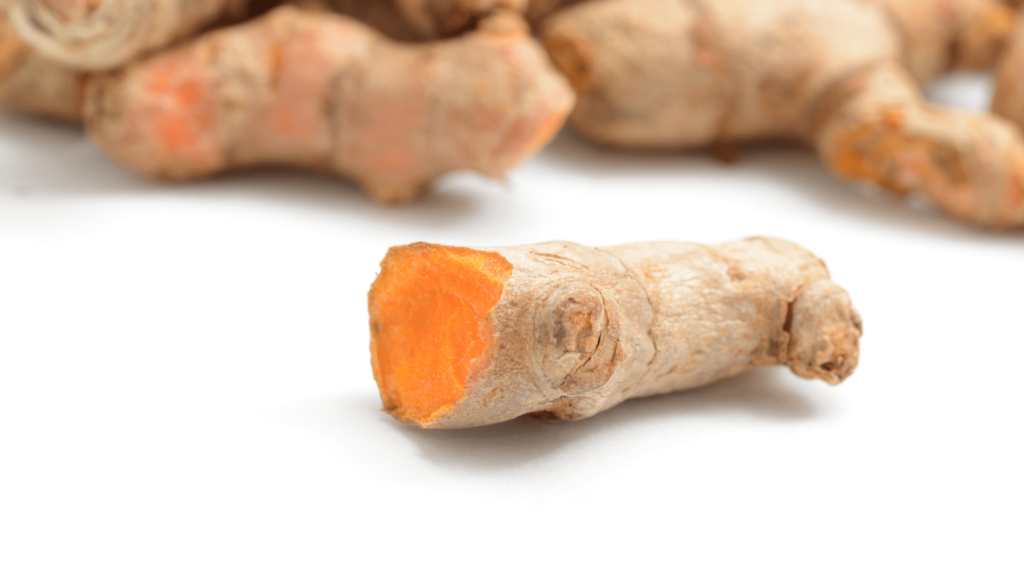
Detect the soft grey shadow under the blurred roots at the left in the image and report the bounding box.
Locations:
[0,115,489,228]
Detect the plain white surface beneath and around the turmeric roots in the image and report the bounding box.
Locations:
[0,73,1024,575]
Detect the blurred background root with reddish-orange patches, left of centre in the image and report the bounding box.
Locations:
[86,6,573,202]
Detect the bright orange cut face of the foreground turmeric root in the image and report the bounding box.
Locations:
[370,244,512,423]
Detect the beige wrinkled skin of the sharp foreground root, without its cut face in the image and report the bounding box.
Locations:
[409,238,861,428]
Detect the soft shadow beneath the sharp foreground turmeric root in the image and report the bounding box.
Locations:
[391,369,819,470]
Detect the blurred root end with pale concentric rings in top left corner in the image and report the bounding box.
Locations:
[10,0,249,70]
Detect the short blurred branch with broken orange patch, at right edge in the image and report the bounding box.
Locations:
[815,60,1024,230]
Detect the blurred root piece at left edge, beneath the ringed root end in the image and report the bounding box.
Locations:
[0,9,86,122]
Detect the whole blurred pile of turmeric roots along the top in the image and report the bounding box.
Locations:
[0,0,1024,229]
